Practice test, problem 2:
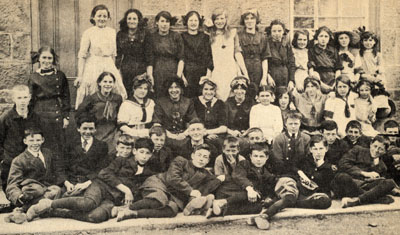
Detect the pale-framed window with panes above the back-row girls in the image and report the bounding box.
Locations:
[290,0,369,31]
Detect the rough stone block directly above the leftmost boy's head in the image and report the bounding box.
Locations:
[0,63,31,89]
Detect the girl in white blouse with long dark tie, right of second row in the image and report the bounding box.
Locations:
[324,75,356,138]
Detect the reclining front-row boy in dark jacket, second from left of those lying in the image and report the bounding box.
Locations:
[117,144,220,221]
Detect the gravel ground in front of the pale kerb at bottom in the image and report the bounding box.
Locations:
[101,211,400,235]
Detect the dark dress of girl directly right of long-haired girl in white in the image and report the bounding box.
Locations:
[238,30,271,97]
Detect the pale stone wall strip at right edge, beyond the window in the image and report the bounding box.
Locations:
[380,0,400,100]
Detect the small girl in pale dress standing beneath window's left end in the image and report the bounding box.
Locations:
[292,30,309,93]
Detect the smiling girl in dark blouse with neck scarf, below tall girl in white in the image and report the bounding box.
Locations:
[76,72,122,151]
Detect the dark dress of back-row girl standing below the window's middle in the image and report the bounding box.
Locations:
[308,44,343,92]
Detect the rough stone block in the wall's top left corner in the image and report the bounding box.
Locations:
[0,0,31,33]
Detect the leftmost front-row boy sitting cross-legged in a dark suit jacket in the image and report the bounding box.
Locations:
[6,127,62,221]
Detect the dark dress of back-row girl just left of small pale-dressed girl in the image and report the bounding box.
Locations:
[268,38,296,87]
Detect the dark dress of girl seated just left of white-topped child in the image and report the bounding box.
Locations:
[225,97,255,131]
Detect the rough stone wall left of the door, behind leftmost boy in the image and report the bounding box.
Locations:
[0,0,31,113]
